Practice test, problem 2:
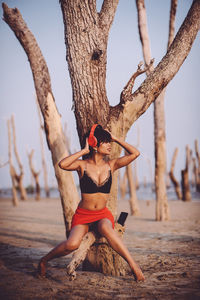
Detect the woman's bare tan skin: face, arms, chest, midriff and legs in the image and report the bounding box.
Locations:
[38,135,144,281]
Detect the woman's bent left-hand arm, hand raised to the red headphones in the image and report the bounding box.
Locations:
[58,140,90,171]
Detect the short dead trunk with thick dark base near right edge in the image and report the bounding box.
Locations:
[181,145,191,201]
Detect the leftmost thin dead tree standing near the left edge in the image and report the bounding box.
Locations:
[7,120,19,206]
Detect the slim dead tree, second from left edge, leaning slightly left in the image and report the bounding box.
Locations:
[11,115,27,200]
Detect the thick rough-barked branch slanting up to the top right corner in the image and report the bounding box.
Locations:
[121,0,200,129]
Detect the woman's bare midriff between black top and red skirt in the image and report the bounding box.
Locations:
[78,193,108,210]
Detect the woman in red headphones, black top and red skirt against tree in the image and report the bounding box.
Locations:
[38,124,144,281]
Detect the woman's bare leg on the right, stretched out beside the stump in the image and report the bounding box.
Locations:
[98,219,144,281]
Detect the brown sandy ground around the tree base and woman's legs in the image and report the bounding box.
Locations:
[0,198,200,300]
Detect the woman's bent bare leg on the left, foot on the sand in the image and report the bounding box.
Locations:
[38,225,89,277]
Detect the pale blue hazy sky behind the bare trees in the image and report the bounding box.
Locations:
[0,0,200,188]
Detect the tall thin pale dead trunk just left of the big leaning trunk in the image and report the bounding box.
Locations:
[35,97,50,197]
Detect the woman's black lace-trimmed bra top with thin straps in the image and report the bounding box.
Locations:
[80,162,112,194]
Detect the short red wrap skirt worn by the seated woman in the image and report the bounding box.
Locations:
[71,207,114,228]
